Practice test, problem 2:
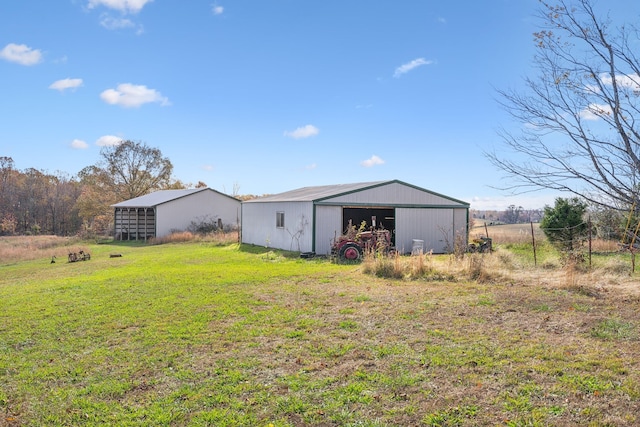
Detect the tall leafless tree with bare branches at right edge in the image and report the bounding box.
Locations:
[486,0,640,209]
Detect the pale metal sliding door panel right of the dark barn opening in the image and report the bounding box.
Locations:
[396,208,454,253]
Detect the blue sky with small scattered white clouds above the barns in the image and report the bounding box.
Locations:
[0,0,637,209]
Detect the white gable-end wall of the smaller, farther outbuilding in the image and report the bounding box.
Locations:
[157,190,240,237]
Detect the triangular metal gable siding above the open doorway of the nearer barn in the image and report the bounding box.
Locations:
[320,183,460,206]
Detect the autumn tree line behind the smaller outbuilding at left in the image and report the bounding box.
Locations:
[0,140,198,237]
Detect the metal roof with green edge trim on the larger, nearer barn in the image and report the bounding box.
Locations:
[244,180,469,205]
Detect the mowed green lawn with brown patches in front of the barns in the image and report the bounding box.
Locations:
[0,242,640,426]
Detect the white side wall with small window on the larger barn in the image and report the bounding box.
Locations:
[242,202,313,252]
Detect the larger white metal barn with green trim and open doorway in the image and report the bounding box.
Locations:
[241,180,469,255]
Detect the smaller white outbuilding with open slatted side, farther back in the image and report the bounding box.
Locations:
[112,188,241,240]
